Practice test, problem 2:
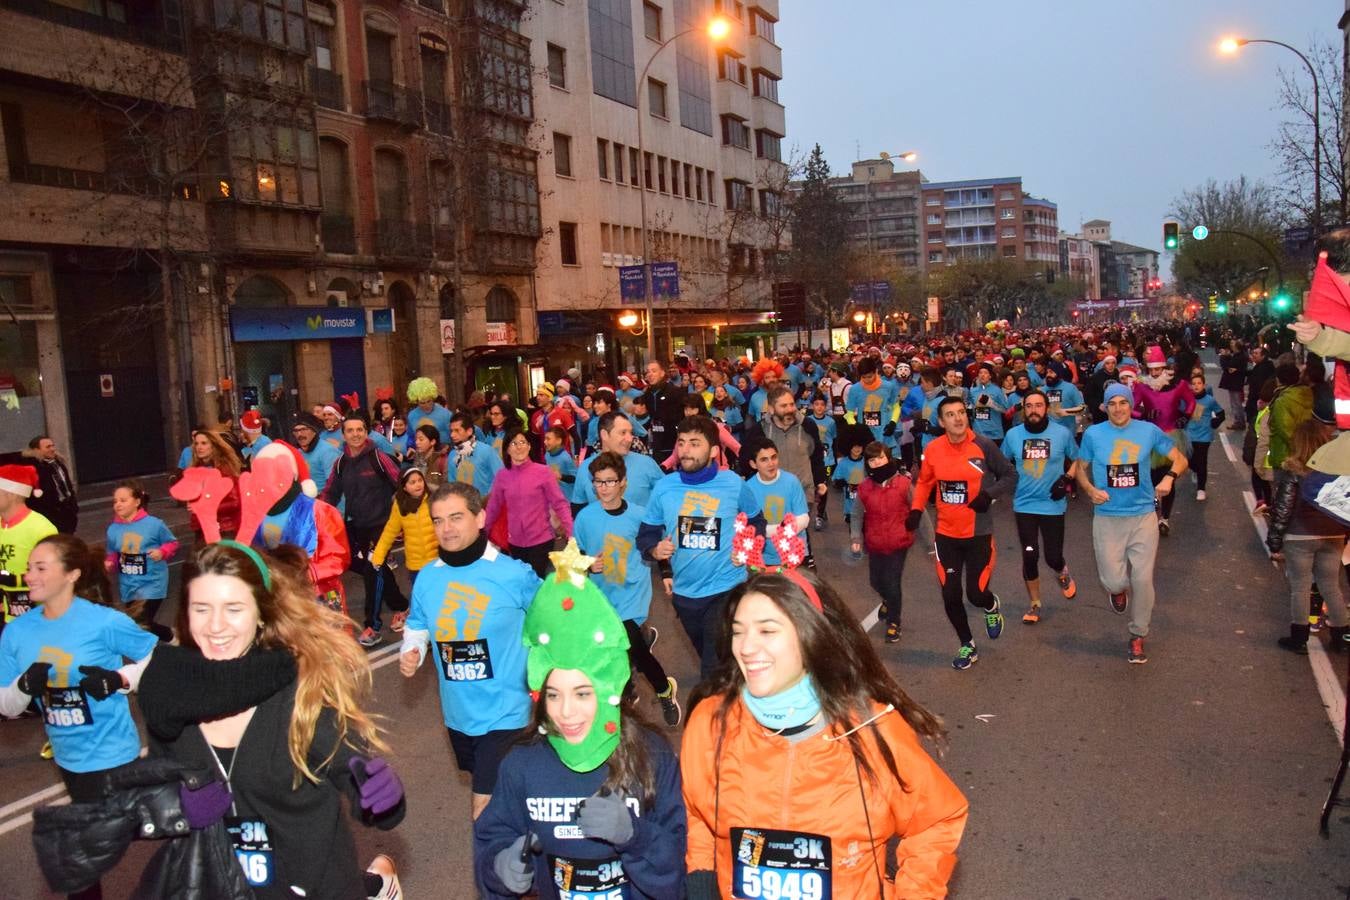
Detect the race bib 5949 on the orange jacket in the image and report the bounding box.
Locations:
[732,828,832,900]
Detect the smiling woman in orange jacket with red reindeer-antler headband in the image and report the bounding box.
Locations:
[680,569,967,900]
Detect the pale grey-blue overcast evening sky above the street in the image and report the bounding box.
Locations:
[776,0,1345,250]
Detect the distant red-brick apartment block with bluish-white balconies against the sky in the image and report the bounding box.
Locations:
[922,177,1060,270]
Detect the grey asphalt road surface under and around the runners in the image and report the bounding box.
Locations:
[0,383,1350,900]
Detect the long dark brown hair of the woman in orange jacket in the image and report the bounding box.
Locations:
[690,572,946,791]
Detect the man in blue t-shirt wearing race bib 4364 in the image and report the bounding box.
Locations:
[637,416,764,679]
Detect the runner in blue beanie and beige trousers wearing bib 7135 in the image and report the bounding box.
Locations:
[1077,383,1187,663]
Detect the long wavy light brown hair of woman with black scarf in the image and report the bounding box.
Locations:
[178,544,387,787]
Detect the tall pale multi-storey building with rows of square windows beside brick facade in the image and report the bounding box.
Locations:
[525,0,787,371]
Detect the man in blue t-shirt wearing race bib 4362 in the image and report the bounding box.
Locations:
[398,482,540,818]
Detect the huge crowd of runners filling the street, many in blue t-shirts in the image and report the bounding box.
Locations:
[0,304,1350,900]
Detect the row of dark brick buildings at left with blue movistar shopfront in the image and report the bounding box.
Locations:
[0,0,543,480]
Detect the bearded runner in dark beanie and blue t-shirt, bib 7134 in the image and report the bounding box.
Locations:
[1003,389,1079,625]
